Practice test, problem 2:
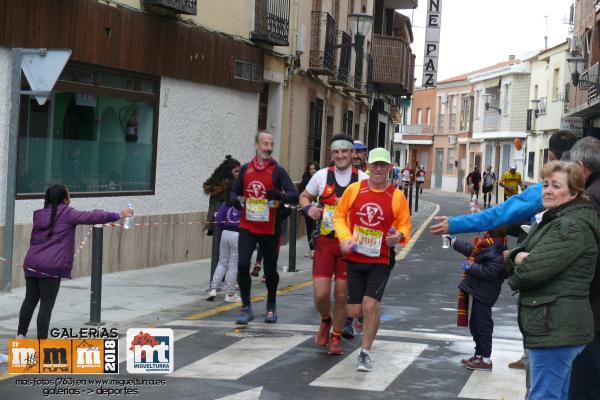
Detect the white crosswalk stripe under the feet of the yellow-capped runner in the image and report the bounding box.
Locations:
[310,340,427,392]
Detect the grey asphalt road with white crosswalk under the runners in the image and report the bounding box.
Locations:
[0,192,524,400]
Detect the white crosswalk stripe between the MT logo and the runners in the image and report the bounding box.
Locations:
[171,335,310,380]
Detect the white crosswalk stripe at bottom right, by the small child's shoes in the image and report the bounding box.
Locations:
[458,349,526,400]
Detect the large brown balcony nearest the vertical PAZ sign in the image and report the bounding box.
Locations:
[372,34,414,96]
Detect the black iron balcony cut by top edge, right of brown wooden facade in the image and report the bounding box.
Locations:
[250,0,290,46]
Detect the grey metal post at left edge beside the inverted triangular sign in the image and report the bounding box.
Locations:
[2,49,23,291]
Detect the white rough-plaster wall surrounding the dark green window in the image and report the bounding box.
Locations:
[0,57,258,224]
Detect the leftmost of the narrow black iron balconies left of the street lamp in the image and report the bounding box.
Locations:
[309,11,335,75]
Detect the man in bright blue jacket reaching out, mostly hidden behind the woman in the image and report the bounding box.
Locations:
[430,131,577,376]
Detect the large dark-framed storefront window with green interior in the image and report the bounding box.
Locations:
[17,66,158,198]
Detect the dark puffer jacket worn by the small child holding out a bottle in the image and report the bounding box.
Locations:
[453,239,506,307]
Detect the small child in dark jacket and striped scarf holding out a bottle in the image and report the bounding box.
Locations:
[442,228,506,371]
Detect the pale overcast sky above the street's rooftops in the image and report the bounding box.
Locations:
[399,0,575,86]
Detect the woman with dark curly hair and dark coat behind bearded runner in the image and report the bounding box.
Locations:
[203,154,241,236]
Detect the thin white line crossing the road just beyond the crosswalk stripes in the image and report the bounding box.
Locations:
[161,320,523,350]
